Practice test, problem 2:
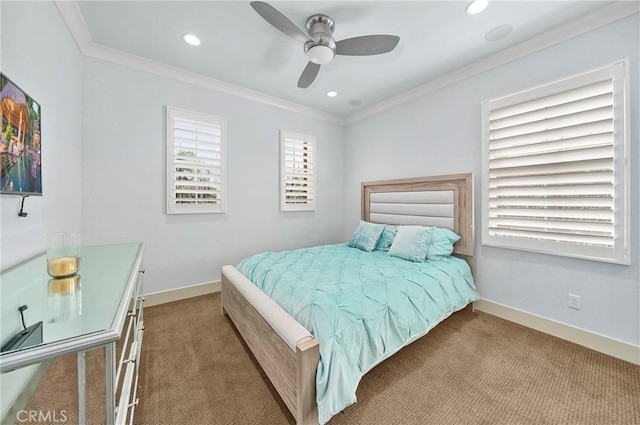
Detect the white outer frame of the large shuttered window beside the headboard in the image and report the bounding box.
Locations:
[482,60,631,265]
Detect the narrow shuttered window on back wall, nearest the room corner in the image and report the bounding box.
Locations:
[280,130,316,211]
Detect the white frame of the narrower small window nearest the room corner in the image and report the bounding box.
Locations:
[280,130,318,212]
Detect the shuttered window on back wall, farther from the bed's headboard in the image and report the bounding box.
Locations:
[167,107,227,214]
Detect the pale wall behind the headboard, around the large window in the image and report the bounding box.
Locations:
[344,15,640,345]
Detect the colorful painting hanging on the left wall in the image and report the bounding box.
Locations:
[0,73,42,195]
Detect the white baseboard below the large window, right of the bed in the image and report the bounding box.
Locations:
[474,300,640,365]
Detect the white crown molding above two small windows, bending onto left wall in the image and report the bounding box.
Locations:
[54,0,345,125]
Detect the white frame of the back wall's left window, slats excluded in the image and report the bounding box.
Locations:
[166,106,228,214]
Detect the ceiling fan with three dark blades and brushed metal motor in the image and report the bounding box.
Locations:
[251,1,400,89]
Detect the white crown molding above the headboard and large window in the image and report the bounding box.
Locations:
[345,1,640,125]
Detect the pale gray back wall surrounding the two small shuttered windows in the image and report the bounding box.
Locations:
[82,59,344,293]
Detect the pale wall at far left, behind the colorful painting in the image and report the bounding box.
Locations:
[0,2,82,417]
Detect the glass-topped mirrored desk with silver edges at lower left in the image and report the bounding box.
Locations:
[0,243,144,424]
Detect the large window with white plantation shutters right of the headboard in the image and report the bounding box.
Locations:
[482,62,630,264]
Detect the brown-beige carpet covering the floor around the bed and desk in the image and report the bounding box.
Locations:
[21,294,640,425]
